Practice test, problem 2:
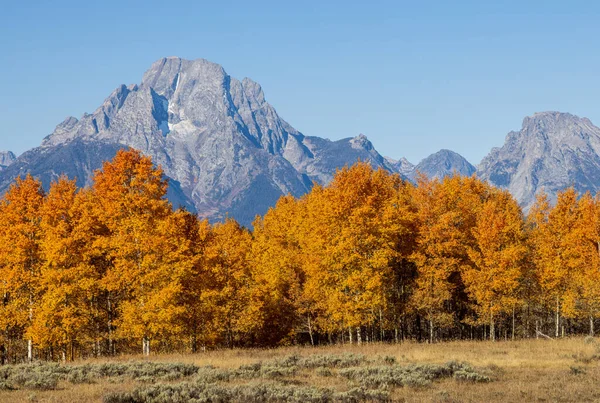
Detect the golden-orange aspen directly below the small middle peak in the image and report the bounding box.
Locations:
[412,175,490,342]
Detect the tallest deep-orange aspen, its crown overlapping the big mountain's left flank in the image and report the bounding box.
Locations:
[92,149,171,355]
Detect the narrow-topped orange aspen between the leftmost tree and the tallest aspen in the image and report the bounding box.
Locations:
[29,177,97,360]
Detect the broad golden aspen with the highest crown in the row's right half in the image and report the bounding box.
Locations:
[300,163,400,343]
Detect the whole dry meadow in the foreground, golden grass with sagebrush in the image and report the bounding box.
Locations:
[0,338,600,403]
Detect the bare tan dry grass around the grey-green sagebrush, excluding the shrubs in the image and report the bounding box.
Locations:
[0,338,600,402]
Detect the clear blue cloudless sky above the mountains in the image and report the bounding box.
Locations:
[0,0,600,163]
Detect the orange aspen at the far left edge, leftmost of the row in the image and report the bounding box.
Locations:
[0,175,44,361]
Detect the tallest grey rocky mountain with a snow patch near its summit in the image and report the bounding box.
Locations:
[0,57,394,225]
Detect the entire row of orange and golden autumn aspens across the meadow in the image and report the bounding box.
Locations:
[0,150,600,362]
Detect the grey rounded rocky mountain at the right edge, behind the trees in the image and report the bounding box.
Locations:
[478,112,600,210]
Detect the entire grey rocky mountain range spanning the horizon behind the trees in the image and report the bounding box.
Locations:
[0,57,600,221]
